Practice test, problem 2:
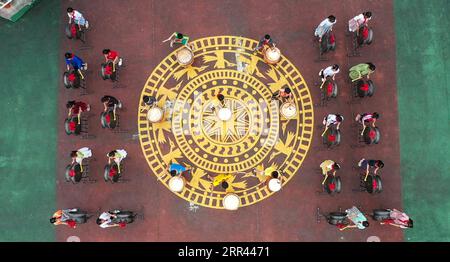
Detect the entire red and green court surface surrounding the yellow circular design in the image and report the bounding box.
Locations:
[0,0,450,241]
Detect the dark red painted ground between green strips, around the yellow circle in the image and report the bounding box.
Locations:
[56,0,403,241]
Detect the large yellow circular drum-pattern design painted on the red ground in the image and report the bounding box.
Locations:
[138,36,314,209]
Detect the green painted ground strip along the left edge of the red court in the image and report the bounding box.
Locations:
[0,0,60,241]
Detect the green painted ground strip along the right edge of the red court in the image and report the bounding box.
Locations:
[395,0,450,241]
